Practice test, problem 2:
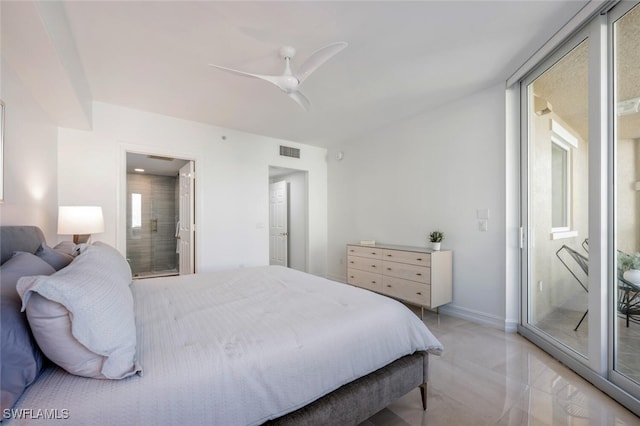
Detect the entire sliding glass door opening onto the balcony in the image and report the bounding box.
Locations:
[519,1,640,414]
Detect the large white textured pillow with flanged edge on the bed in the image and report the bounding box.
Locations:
[17,244,141,379]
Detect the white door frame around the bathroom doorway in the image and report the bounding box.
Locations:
[116,142,196,272]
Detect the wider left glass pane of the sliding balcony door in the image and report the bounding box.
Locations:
[523,40,589,358]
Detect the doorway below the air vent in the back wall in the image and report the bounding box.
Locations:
[269,166,309,272]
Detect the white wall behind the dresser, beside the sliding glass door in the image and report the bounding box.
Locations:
[328,85,506,328]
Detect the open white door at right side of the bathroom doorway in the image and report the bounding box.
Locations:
[177,161,195,275]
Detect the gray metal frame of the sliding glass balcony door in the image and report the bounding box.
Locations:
[507,2,640,415]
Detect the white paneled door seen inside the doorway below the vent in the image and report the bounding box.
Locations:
[269,181,289,266]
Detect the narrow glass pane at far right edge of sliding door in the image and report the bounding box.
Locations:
[613,6,640,384]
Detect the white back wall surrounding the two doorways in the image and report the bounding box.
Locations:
[58,102,327,275]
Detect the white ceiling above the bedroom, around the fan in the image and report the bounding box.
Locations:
[2,0,585,146]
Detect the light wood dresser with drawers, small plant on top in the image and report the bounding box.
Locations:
[347,244,453,309]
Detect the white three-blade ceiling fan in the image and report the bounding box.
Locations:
[209,42,347,111]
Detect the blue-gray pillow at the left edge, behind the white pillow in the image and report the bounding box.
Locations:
[0,252,55,412]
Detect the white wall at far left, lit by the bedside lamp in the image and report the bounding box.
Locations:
[0,62,58,241]
